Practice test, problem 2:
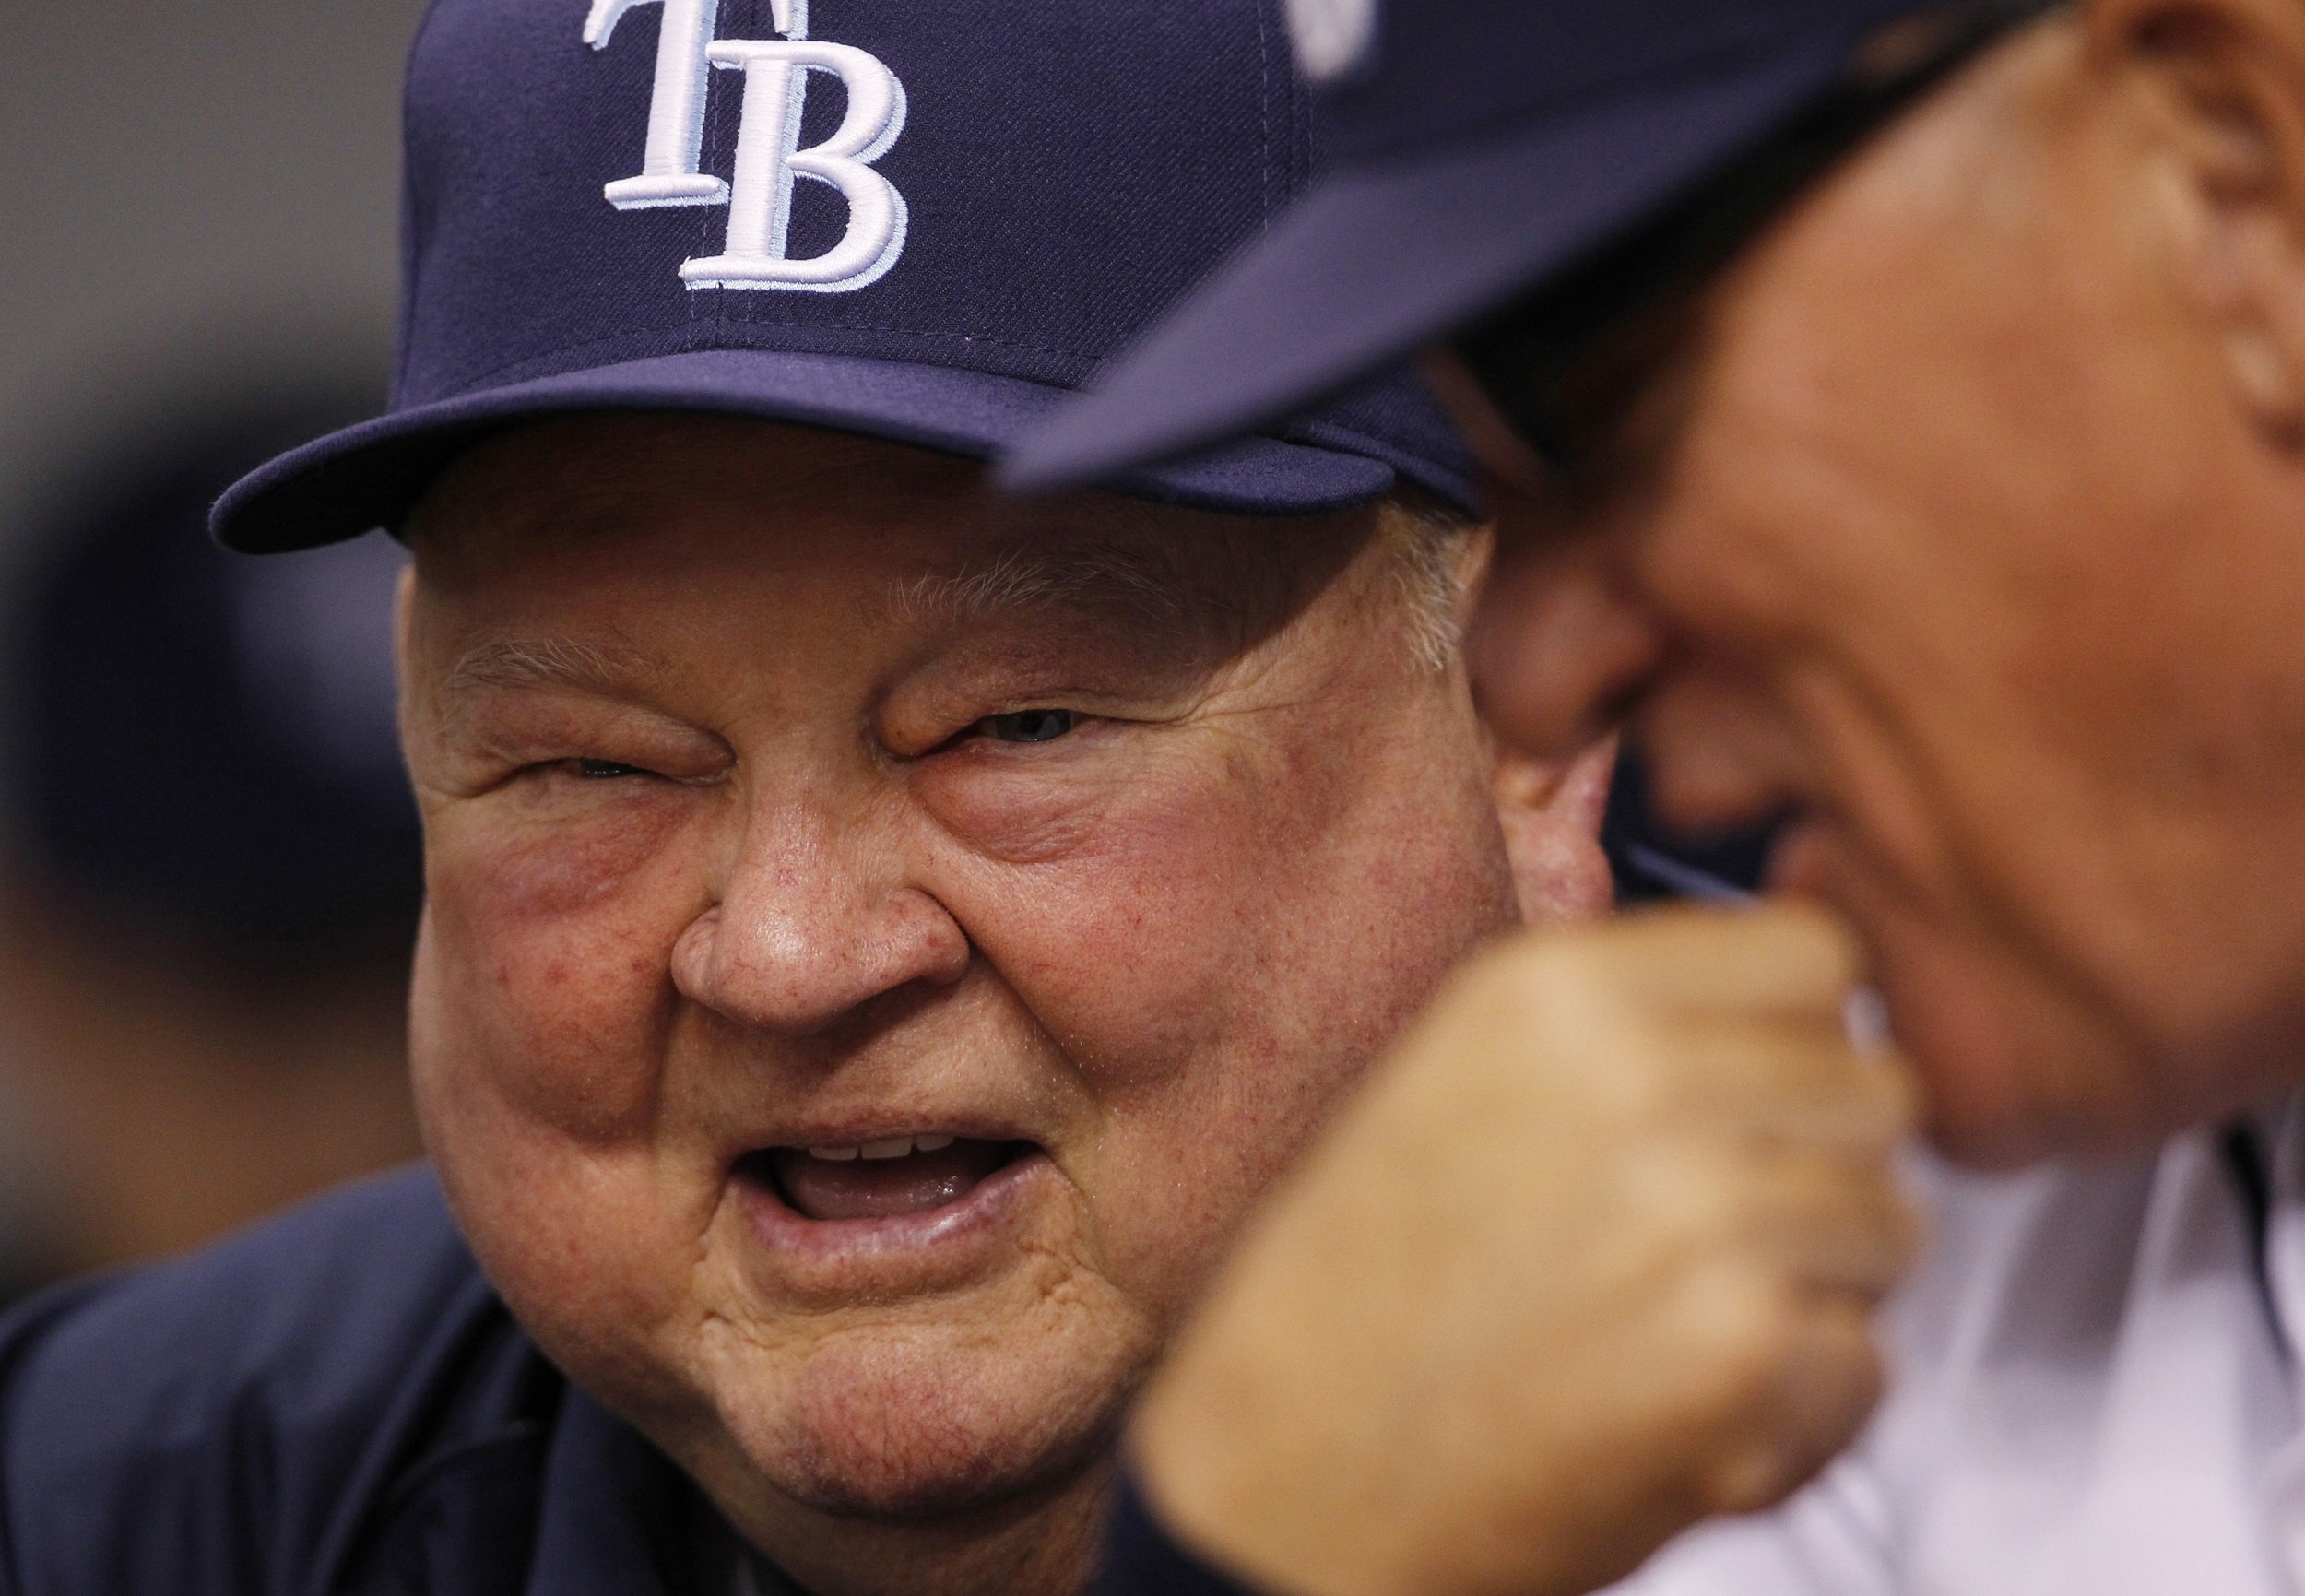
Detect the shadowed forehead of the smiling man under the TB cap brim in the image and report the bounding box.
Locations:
[408,415,1378,632]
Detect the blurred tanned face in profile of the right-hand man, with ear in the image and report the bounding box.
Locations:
[1478,0,2305,1163]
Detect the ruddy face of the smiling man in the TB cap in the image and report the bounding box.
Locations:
[392,418,1607,1564]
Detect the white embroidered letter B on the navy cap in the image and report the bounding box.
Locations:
[680,40,906,293]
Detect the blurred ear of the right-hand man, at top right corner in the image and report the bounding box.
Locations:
[2088,0,2305,450]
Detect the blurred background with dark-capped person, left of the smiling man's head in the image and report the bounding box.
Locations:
[0,0,422,1296]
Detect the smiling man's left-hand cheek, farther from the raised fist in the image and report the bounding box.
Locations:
[413,817,728,1407]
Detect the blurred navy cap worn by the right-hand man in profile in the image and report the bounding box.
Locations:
[1003,0,2047,491]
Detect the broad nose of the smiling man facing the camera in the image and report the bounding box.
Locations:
[673,803,971,1035]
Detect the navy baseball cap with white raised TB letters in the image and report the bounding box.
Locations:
[212,0,1471,551]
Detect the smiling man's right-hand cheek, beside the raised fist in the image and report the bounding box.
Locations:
[927,710,1515,1317]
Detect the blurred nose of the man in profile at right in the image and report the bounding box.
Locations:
[1471,516,1667,759]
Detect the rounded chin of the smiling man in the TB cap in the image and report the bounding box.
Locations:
[717,1300,1151,1522]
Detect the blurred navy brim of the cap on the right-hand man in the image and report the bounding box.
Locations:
[1000,30,1851,491]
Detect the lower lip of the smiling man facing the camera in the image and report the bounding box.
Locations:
[733,1151,1056,1296]
